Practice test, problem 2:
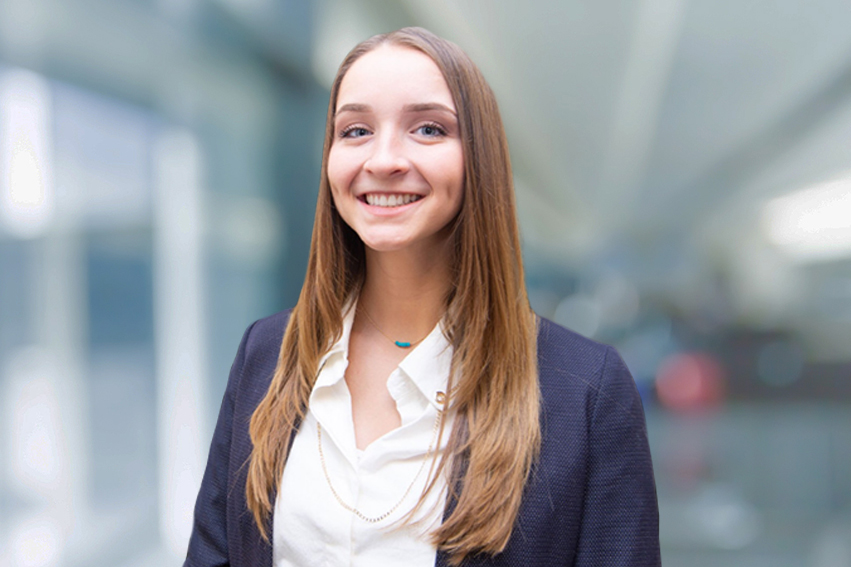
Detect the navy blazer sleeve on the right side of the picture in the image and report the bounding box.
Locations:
[575,347,661,567]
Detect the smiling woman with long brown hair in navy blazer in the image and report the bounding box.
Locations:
[186,28,660,567]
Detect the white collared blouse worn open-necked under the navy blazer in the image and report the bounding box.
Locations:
[272,307,452,567]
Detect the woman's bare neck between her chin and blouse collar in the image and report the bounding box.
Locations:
[358,245,450,339]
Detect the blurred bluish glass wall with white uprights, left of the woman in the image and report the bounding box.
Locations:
[0,2,327,567]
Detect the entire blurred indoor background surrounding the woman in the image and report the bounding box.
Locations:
[0,0,851,567]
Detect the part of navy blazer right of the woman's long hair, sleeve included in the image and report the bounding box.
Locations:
[536,319,661,566]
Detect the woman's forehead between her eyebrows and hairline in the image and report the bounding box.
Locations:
[337,45,455,110]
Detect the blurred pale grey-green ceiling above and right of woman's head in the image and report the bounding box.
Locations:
[316,0,851,258]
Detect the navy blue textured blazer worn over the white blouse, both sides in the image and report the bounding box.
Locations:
[184,312,661,567]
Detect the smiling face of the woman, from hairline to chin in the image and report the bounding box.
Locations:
[328,45,464,252]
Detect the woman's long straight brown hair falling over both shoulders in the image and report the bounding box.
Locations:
[245,28,540,564]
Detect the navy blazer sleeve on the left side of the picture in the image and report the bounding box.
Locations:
[183,324,254,567]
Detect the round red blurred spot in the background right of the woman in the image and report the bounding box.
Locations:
[656,353,725,412]
